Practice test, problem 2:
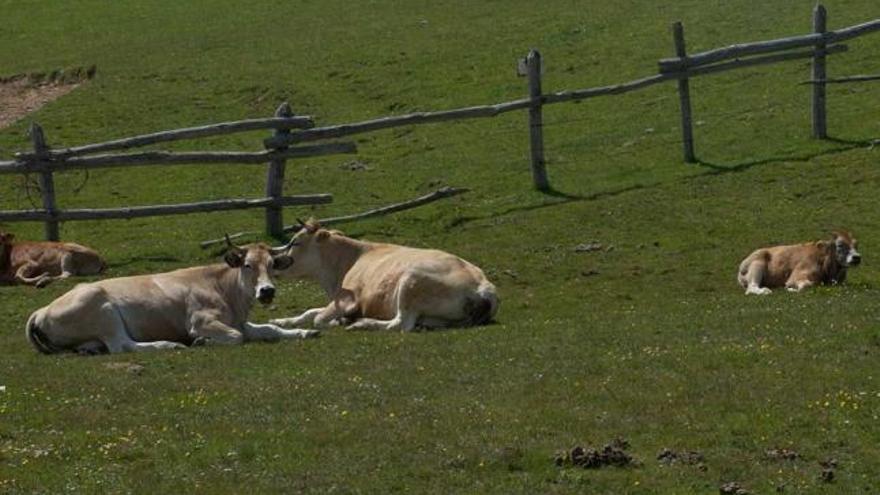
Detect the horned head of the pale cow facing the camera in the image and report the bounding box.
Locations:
[223,236,293,304]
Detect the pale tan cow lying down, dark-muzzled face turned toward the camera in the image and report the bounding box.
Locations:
[26,238,318,354]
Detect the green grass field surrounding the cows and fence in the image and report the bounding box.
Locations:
[0,0,880,494]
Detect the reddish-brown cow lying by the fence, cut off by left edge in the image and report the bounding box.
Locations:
[0,231,106,287]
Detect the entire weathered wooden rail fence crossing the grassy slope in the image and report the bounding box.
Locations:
[0,5,880,239]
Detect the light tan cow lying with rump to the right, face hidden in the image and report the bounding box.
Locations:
[272,221,498,331]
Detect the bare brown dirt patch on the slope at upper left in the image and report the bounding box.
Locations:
[0,66,95,129]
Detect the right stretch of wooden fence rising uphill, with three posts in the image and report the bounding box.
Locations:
[265,5,880,178]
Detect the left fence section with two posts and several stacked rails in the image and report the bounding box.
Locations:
[0,103,357,240]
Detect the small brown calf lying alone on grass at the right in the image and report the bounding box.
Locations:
[737,231,862,295]
